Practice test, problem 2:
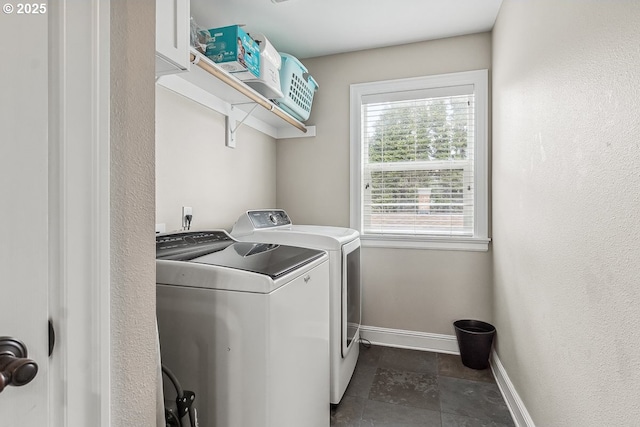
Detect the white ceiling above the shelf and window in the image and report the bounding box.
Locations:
[191,0,502,59]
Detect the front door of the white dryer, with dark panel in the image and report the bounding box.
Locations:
[341,239,362,357]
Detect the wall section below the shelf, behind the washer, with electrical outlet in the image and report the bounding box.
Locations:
[156,85,276,231]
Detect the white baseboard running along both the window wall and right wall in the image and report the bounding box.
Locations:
[360,325,535,427]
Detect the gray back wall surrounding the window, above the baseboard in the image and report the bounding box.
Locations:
[277,33,492,335]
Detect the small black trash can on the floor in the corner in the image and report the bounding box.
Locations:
[453,320,496,369]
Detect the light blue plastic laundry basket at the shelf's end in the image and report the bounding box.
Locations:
[275,53,318,122]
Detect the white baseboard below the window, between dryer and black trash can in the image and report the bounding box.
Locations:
[360,325,460,354]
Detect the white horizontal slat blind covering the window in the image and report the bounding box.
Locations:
[362,93,474,236]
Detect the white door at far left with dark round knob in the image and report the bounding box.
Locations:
[0,0,49,427]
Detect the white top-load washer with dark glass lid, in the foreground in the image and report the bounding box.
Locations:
[156,230,329,427]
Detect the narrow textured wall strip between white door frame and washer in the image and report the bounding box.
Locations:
[110,0,157,427]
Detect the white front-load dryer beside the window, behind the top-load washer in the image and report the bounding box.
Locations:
[231,209,361,404]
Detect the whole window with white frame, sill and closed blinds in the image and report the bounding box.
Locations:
[351,70,489,250]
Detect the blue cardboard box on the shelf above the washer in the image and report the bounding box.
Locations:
[205,25,260,80]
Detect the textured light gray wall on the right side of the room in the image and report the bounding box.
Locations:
[493,0,640,426]
